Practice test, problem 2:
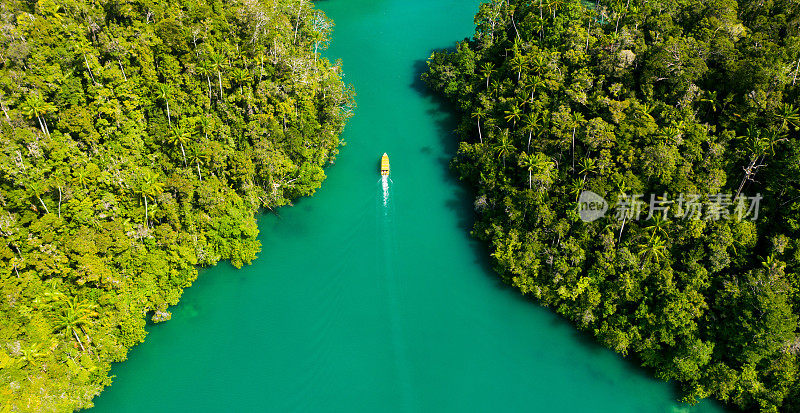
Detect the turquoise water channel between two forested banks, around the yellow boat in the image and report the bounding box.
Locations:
[94,0,721,412]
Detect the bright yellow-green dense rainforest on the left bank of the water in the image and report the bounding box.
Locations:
[0,0,352,411]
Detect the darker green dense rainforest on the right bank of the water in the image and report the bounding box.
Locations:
[423,0,800,412]
